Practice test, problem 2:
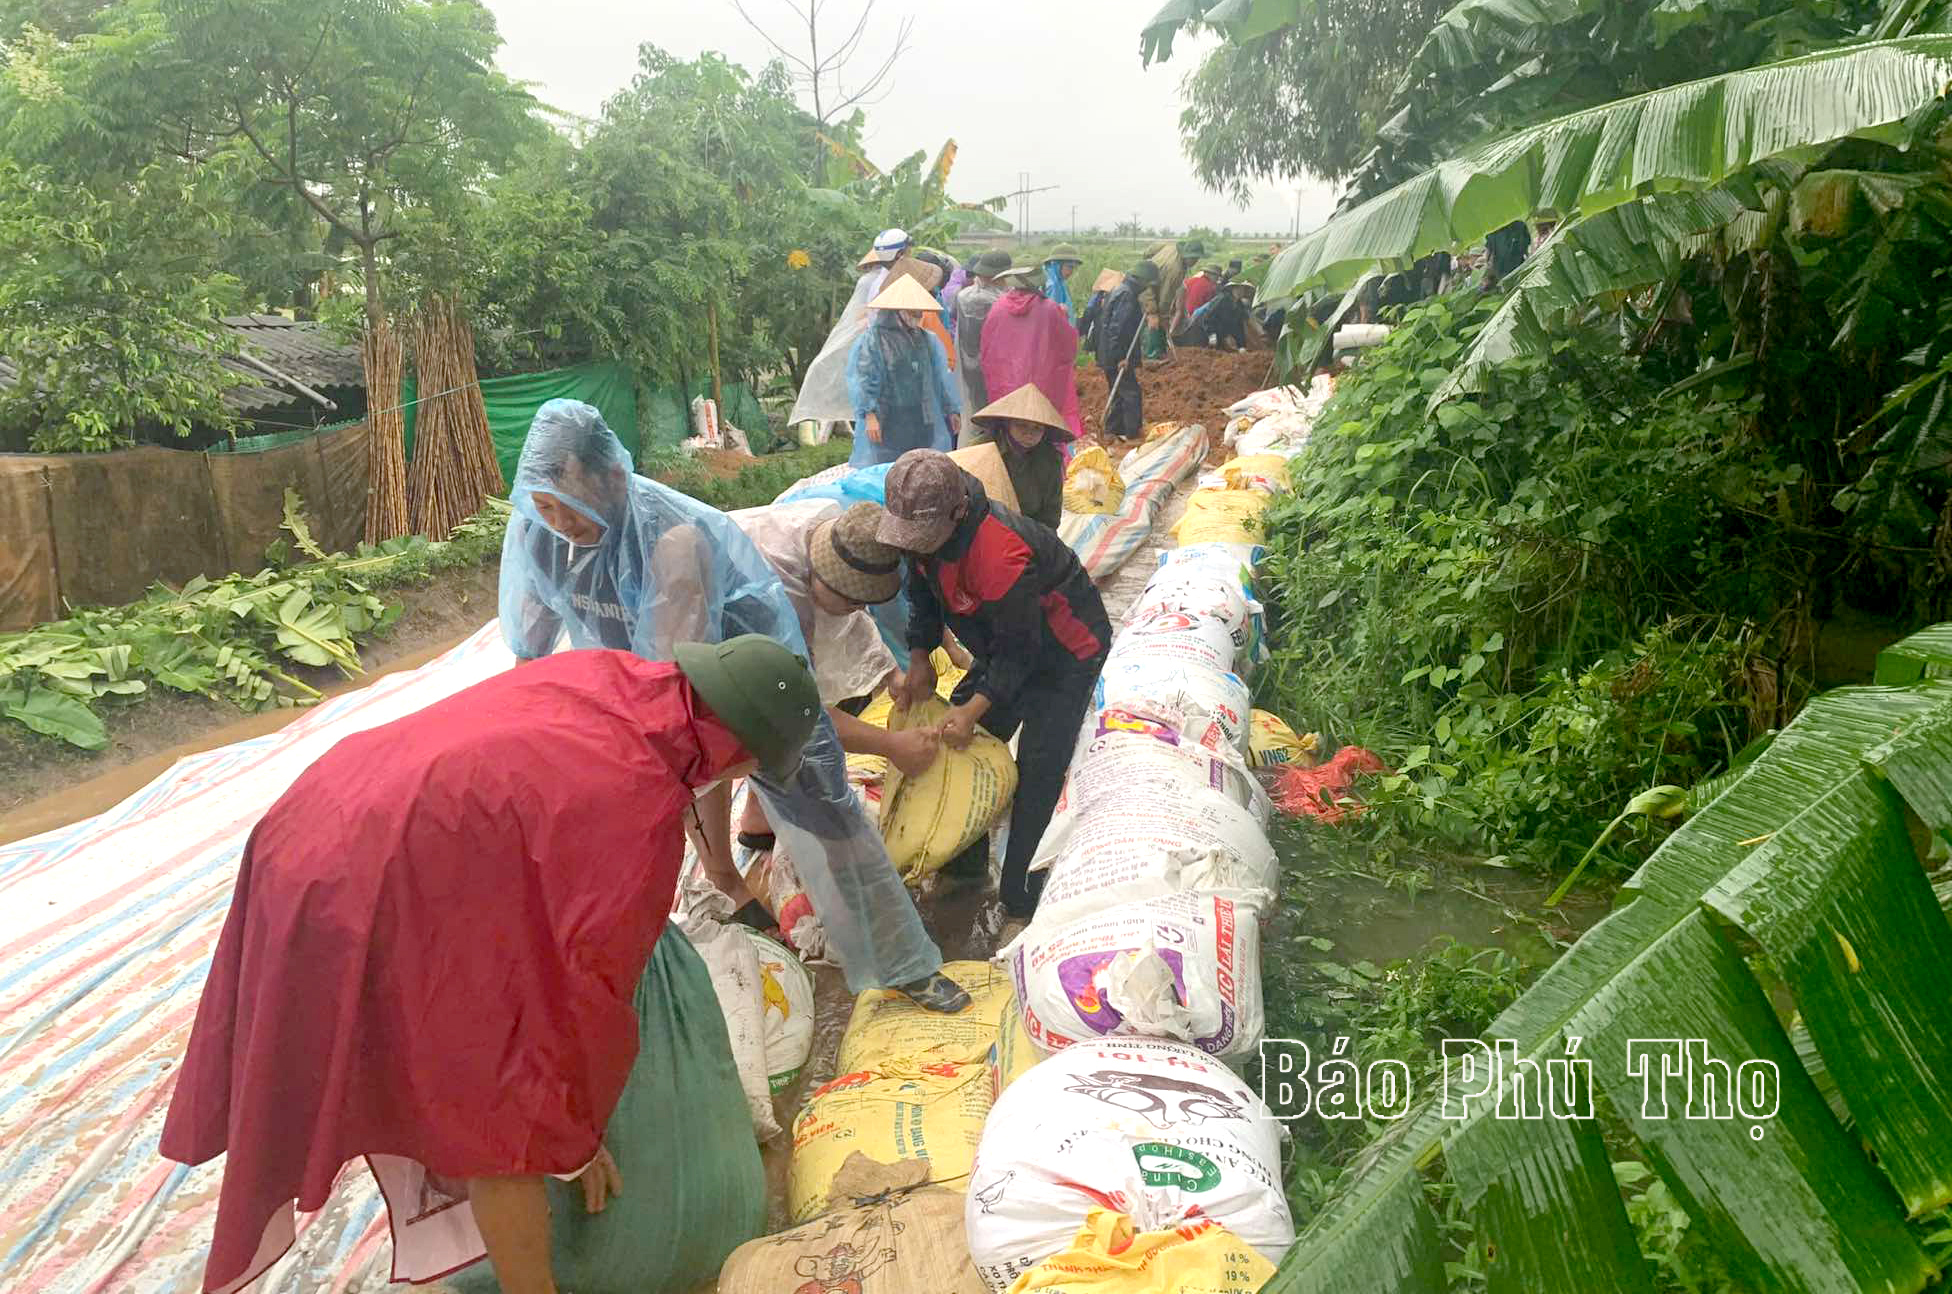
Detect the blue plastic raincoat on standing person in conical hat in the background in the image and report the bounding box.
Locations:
[847,310,962,466]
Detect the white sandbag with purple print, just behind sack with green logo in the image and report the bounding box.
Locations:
[997,890,1265,1056]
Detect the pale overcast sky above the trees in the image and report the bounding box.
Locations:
[486,0,1333,232]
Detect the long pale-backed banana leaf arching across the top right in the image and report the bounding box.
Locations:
[1263,35,1952,301]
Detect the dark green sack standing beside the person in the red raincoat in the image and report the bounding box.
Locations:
[447,925,765,1294]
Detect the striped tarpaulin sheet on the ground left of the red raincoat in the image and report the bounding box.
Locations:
[0,623,513,1294]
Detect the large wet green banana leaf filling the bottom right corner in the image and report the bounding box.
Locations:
[1267,681,1952,1294]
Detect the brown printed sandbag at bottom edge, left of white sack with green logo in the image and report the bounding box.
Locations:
[722,1187,986,1294]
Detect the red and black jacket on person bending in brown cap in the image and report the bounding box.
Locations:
[908,472,1111,707]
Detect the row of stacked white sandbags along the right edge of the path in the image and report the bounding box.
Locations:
[966,519,1294,1294]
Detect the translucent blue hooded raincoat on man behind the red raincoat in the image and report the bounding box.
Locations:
[502,400,943,991]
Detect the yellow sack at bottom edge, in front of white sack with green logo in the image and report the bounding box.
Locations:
[1009,1208,1275,1294]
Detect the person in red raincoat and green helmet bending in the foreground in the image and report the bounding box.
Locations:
[162,634,820,1294]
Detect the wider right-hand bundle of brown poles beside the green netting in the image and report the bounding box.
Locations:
[406,295,502,539]
